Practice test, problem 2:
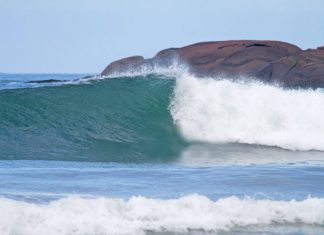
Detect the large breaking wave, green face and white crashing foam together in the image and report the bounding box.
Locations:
[0,71,324,162]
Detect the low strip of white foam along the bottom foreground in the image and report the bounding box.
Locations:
[0,195,324,235]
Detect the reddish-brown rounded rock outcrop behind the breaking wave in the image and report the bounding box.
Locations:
[101,40,324,88]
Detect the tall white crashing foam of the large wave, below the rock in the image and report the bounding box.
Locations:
[171,74,324,150]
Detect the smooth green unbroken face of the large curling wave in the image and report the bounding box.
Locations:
[0,75,184,162]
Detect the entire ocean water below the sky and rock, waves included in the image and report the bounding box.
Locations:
[0,70,324,235]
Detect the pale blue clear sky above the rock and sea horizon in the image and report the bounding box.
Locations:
[0,0,324,73]
